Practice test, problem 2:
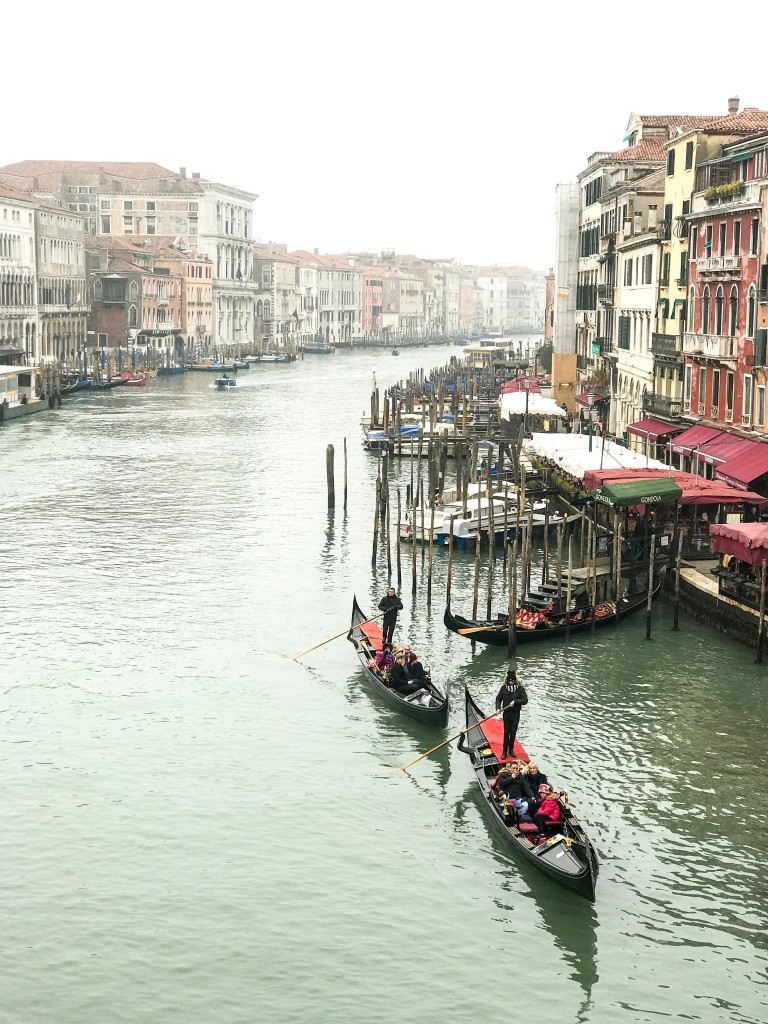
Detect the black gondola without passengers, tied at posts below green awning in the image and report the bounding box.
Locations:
[442,575,663,647]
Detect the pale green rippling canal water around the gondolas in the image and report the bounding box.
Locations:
[0,348,768,1024]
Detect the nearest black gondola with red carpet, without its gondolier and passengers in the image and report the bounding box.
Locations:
[459,689,599,901]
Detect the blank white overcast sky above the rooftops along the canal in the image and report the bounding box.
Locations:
[6,0,768,269]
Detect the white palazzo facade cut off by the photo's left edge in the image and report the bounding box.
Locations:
[0,179,40,367]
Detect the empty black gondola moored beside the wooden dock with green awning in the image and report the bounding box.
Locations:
[442,575,664,647]
